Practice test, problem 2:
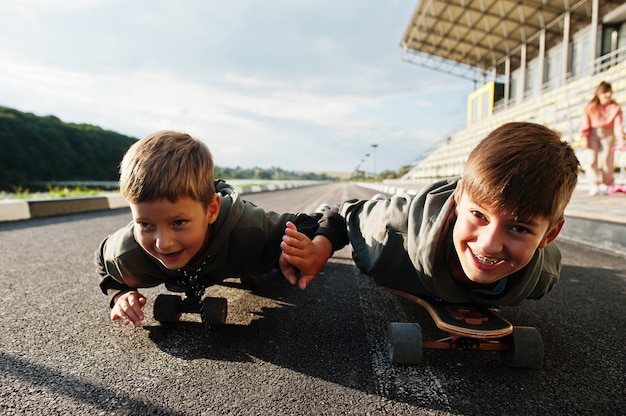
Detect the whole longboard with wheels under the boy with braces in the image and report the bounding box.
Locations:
[385,288,543,368]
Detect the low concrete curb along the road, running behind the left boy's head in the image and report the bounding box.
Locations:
[0,181,327,223]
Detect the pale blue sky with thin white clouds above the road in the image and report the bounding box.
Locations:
[0,0,472,176]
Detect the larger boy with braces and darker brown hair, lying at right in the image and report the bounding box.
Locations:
[332,122,579,306]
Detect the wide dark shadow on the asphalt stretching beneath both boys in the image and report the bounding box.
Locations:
[136,264,626,414]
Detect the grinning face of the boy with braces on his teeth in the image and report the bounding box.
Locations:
[453,192,563,284]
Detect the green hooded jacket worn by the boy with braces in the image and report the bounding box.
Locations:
[341,180,561,306]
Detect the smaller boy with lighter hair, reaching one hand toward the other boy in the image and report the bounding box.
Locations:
[96,131,346,326]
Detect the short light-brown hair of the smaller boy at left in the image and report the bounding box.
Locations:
[120,131,215,208]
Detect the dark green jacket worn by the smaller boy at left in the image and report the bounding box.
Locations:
[96,181,338,306]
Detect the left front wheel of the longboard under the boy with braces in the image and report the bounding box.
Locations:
[388,322,422,364]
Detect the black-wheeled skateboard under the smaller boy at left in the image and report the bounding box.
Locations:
[153,280,228,326]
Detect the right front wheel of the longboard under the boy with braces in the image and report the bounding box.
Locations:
[503,326,543,368]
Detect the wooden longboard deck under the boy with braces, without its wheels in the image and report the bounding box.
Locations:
[386,288,513,338]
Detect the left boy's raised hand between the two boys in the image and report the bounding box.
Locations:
[278,222,333,290]
